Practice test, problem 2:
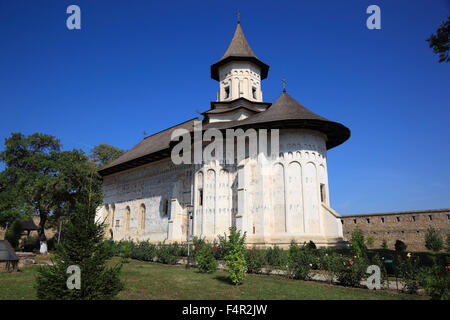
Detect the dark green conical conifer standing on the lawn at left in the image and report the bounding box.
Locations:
[36,164,124,300]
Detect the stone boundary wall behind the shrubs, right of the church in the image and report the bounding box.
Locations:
[341,209,450,251]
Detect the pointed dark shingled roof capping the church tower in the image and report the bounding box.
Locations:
[211,22,269,81]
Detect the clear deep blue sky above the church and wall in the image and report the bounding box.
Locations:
[0,0,450,214]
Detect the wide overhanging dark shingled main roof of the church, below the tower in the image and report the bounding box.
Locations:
[99,92,350,176]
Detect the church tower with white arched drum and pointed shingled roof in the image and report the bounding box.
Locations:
[211,21,269,102]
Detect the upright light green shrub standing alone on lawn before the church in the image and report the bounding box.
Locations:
[225,227,247,285]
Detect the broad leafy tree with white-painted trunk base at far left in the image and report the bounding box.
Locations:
[0,133,100,253]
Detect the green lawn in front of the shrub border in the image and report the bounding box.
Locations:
[0,258,424,300]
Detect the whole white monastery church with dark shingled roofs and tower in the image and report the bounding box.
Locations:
[97,22,350,247]
